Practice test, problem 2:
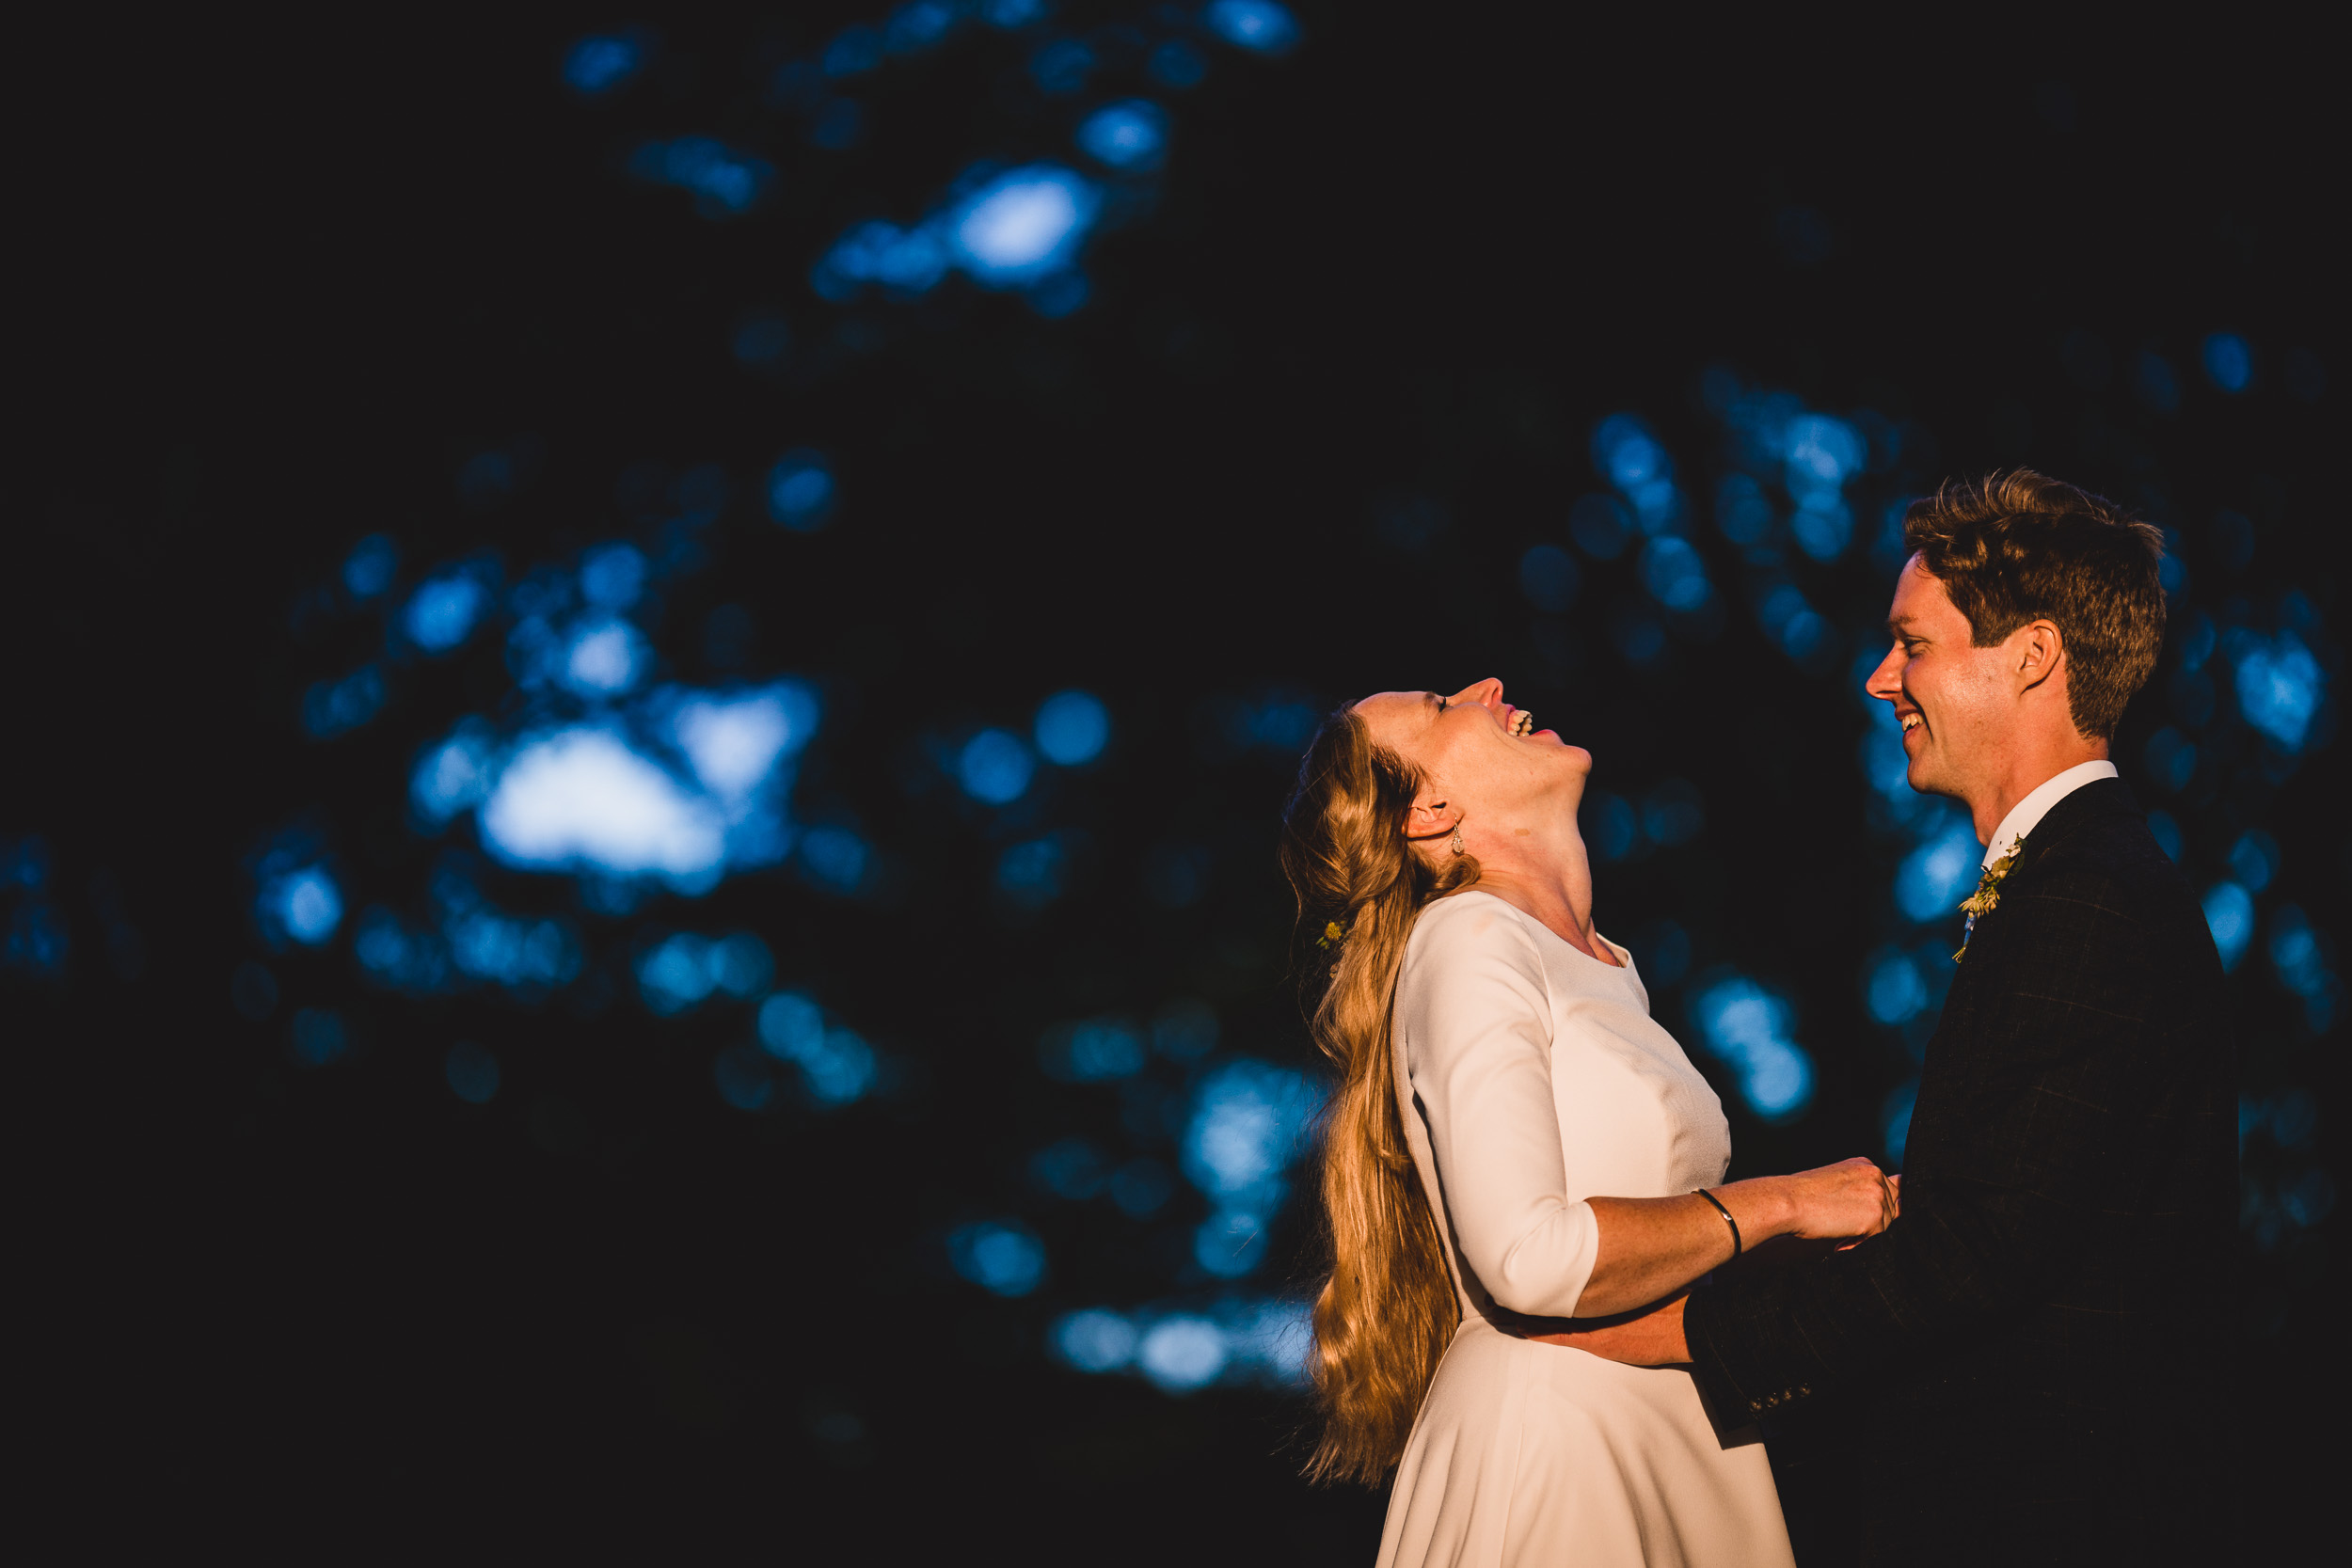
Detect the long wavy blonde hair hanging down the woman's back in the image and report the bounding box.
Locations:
[1282,707,1477,1486]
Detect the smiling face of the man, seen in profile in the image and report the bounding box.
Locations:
[1866,555,2016,800]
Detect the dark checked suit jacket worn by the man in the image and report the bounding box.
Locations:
[1684,778,2237,1566]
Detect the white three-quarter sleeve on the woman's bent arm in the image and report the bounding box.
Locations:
[1397,898,1599,1317]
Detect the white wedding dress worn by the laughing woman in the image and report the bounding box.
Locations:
[1381,894,1795,1568]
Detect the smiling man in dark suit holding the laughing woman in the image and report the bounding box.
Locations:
[1562,472,2237,1568]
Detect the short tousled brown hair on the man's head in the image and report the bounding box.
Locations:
[1903,467,2164,740]
